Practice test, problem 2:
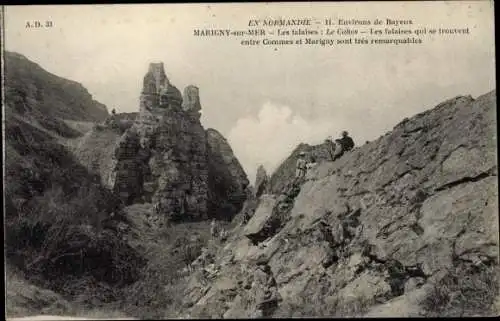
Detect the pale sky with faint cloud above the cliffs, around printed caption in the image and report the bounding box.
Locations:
[4,1,496,182]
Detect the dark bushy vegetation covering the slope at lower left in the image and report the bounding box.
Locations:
[5,113,145,295]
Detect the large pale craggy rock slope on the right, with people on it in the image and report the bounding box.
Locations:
[183,92,499,318]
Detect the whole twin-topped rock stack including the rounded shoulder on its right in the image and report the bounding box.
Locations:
[112,63,248,221]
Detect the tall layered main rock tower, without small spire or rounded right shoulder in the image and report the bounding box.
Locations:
[114,63,208,220]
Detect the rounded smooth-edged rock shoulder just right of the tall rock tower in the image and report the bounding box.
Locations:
[206,128,249,220]
